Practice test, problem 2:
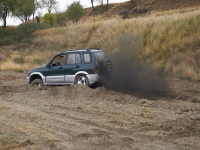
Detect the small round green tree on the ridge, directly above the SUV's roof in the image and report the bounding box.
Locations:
[66,2,84,24]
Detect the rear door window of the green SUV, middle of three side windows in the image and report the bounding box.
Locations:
[65,53,81,65]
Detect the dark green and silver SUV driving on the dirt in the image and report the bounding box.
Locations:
[27,48,112,86]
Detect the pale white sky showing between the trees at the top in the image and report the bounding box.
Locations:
[0,0,129,25]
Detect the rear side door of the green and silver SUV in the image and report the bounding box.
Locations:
[64,52,82,84]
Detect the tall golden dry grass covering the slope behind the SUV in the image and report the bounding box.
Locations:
[0,9,200,81]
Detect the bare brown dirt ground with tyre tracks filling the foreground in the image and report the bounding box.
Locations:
[0,72,200,150]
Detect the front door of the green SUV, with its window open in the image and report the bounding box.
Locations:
[46,55,66,85]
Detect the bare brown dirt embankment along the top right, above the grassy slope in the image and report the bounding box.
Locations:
[81,0,200,22]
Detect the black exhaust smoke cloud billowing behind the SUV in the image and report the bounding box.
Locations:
[105,34,169,99]
